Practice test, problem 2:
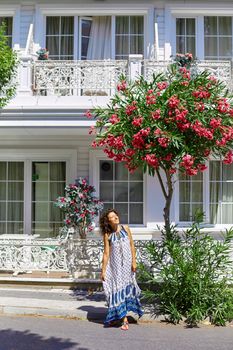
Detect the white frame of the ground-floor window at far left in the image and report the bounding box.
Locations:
[0,149,77,235]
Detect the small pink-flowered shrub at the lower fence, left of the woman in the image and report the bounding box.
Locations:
[55,178,103,277]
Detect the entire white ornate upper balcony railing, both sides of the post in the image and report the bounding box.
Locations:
[32,55,232,96]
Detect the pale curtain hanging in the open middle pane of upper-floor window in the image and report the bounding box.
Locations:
[87,16,111,60]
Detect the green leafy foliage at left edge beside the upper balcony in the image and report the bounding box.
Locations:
[0,25,18,108]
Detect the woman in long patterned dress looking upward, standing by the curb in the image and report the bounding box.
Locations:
[100,209,143,330]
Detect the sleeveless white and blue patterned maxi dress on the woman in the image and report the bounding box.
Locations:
[103,226,143,324]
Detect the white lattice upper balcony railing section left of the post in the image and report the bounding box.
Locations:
[33,60,128,96]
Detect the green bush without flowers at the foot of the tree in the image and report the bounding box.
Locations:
[139,221,233,326]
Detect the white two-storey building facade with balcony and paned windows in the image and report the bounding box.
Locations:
[0,0,233,241]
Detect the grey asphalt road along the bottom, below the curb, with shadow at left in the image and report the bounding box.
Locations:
[0,316,233,350]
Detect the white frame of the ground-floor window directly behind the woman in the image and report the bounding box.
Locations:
[89,150,146,228]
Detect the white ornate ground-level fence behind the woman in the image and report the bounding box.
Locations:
[0,237,149,276]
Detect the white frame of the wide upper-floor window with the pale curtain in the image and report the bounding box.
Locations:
[35,3,154,60]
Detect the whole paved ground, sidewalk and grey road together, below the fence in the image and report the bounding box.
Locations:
[0,287,233,350]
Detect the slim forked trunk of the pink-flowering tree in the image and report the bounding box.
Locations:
[156,169,173,239]
